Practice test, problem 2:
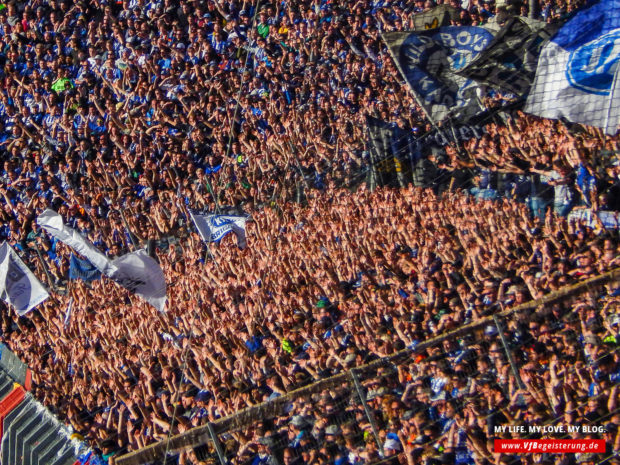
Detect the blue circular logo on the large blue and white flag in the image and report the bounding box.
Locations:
[566,29,620,95]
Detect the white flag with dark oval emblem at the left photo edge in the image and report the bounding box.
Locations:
[0,242,49,316]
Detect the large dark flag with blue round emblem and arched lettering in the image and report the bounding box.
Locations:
[384,26,493,122]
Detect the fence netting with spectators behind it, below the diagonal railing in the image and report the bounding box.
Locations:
[117,272,620,465]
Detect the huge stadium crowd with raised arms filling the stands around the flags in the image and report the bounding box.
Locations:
[0,0,620,464]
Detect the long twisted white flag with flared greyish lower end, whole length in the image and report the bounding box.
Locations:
[37,210,166,311]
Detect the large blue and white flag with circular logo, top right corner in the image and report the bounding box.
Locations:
[525,0,620,134]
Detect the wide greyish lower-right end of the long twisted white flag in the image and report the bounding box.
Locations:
[111,250,166,312]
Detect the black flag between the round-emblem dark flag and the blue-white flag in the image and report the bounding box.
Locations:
[458,16,559,96]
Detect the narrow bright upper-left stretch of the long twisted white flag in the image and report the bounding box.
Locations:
[37,209,116,276]
